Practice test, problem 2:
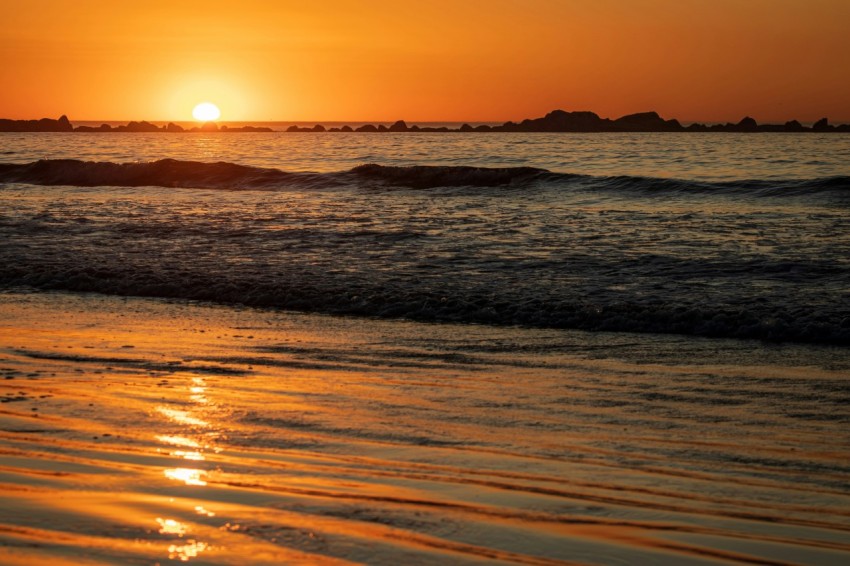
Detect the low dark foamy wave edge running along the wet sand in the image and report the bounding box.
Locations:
[0,265,850,346]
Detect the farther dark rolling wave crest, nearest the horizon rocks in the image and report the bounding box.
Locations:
[0,159,850,197]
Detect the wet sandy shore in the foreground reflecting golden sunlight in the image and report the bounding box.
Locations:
[0,293,850,564]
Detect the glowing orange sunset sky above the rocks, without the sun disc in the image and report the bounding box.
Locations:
[0,0,850,122]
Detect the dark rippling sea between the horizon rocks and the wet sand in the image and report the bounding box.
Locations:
[0,132,850,345]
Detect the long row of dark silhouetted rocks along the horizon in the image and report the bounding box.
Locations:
[0,110,850,133]
